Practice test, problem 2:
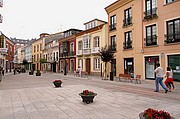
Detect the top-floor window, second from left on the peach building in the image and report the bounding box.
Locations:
[124,8,132,26]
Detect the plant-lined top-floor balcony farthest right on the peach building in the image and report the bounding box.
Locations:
[144,8,158,21]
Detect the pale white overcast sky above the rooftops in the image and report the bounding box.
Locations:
[0,0,116,39]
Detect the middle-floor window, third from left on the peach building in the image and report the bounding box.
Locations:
[146,24,157,46]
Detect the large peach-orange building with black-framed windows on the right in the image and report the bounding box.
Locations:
[105,0,180,80]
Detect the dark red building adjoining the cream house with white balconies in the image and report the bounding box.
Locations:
[59,29,81,75]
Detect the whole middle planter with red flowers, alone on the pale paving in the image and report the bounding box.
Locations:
[79,90,97,104]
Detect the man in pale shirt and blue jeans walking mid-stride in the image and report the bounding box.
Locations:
[154,63,168,93]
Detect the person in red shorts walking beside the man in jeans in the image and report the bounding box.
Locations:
[165,67,175,91]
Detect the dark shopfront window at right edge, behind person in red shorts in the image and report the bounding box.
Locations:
[167,54,180,81]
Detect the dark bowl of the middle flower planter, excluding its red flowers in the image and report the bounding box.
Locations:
[79,93,97,104]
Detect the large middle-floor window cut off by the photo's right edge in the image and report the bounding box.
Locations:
[166,18,180,43]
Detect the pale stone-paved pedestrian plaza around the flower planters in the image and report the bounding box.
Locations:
[0,73,180,119]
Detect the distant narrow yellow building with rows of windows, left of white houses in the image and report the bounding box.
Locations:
[32,33,49,70]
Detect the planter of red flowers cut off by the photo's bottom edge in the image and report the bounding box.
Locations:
[139,108,175,119]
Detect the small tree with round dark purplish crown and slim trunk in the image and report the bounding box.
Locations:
[99,45,115,79]
